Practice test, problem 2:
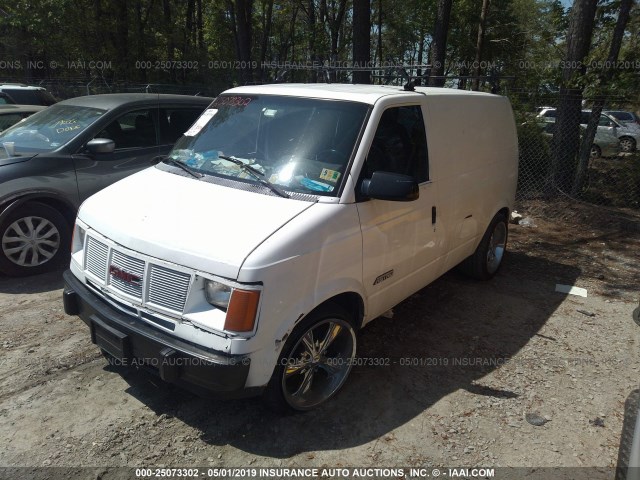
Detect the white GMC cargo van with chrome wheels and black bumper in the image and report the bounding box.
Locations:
[64,84,518,410]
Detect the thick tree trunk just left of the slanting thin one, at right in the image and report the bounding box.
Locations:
[548,0,598,194]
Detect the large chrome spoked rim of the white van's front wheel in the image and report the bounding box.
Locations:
[282,318,356,410]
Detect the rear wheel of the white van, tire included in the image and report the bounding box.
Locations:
[460,212,509,280]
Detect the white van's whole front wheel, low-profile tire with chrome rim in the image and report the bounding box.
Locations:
[263,304,357,413]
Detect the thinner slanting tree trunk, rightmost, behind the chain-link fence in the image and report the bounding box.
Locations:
[571,0,633,195]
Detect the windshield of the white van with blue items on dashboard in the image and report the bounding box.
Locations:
[170,95,368,196]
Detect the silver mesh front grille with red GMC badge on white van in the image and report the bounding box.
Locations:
[85,236,191,314]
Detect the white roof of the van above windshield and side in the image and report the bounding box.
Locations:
[223,83,497,105]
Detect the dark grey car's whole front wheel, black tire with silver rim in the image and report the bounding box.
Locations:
[0,202,71,277]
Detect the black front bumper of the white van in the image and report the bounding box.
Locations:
[63,270,259,398]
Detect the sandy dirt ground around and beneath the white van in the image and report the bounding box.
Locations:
[0,203,640,478]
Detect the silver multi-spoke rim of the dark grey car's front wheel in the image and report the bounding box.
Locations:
[2,216,60,267]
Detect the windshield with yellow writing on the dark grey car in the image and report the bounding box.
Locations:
[0,104,106,154]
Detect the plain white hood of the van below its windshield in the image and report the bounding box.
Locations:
[78,167,313,279]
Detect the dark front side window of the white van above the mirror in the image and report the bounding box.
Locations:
[363,105,429,183]
